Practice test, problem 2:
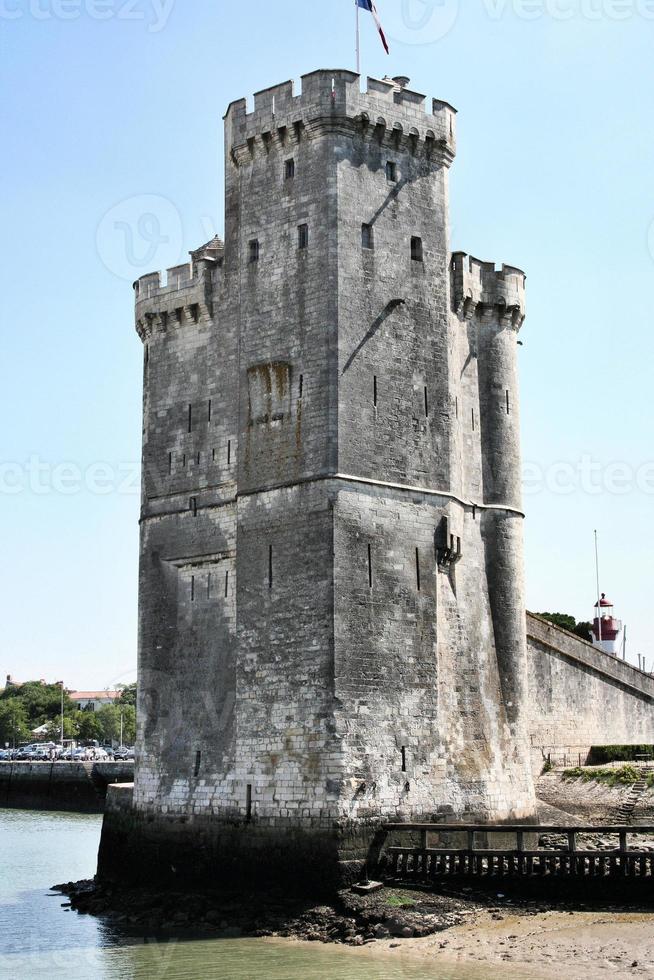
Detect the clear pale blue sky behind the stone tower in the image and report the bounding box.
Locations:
[0,0,654,688]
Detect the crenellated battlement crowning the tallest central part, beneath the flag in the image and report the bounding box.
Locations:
[225,69,456,165]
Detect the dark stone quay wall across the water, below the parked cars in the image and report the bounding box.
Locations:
[0,762,134,813]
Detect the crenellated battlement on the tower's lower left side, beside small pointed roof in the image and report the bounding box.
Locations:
[134,236,224,340]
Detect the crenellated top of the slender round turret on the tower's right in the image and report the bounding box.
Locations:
[450,252,527,329]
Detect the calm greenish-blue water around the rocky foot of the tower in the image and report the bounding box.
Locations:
[0,810,532,980]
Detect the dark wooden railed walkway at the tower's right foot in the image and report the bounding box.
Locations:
[382,824,654,885]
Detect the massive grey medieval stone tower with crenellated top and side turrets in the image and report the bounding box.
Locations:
[113,71,535,880]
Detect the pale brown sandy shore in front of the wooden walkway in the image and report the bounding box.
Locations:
[357,912,654,980]
